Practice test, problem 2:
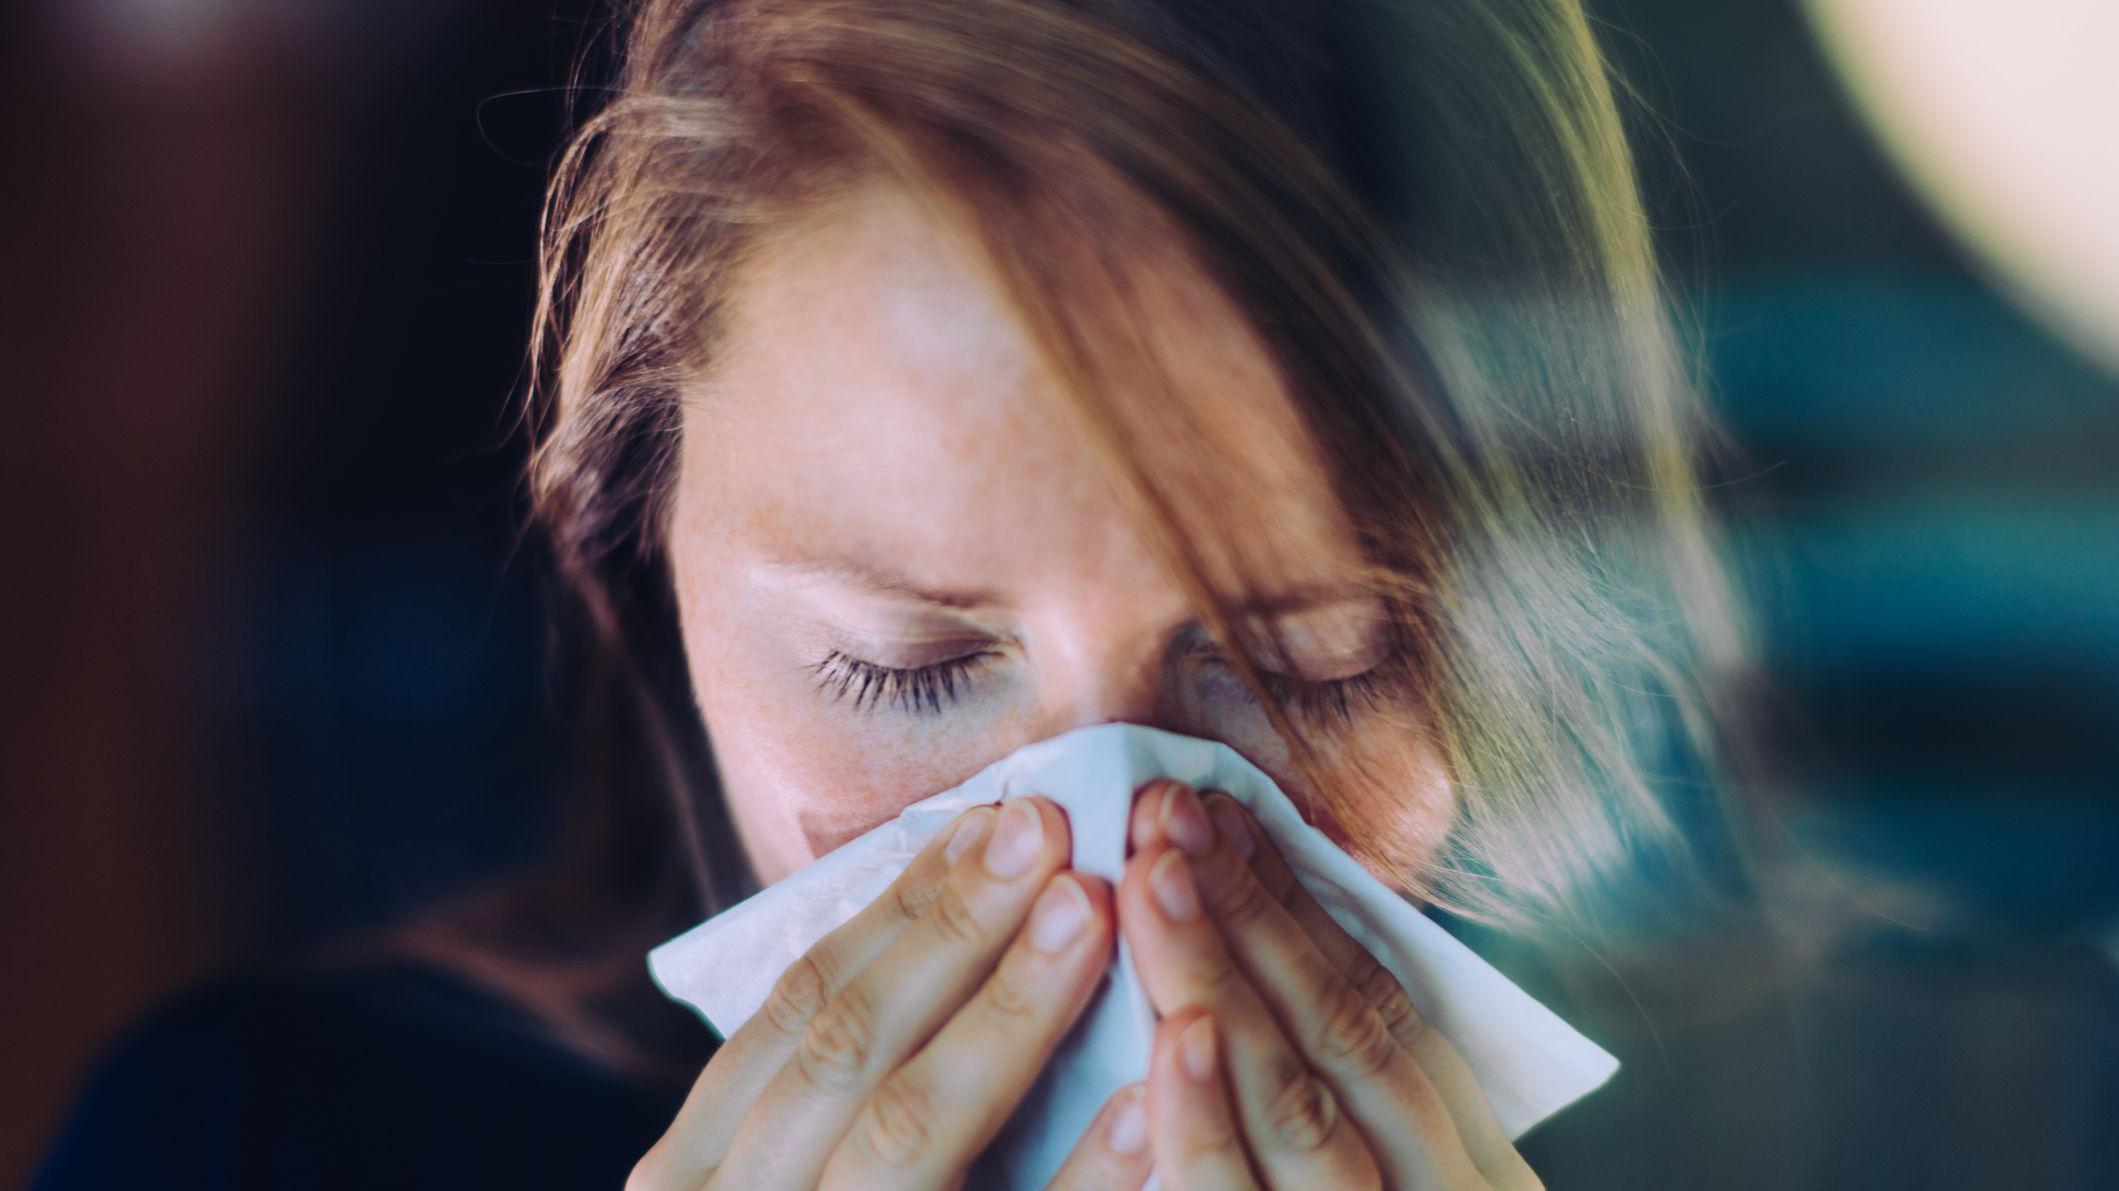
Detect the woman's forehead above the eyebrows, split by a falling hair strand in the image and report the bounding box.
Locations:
[684,184,1354,585]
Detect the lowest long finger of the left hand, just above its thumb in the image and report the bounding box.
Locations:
[822,873,1115,1191]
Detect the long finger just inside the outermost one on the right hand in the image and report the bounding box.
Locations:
[1168,786,1477,1187]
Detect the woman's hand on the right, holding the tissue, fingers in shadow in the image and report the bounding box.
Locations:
[1119,782,1541,1191]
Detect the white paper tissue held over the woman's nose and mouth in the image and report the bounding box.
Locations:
[648,723,1619,1189]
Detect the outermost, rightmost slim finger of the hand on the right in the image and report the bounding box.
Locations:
[1206,793,1521,1176]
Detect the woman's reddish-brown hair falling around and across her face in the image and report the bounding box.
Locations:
[495,0,1742,1059]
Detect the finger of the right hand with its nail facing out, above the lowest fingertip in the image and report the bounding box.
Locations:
[1119,839,1377,1187]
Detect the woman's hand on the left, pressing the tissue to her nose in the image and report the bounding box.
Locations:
[627,797,1148,1191]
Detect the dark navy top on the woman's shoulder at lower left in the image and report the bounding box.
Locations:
[34,962,684,1191]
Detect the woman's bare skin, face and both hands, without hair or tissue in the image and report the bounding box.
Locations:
[634,186,1536,1189]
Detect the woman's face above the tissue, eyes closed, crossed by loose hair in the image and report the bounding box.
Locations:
[670,175,1449,882]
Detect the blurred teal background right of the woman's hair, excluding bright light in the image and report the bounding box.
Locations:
[1530,0,2119,1189]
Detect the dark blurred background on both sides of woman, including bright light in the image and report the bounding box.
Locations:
[0,0,2119,1187]
